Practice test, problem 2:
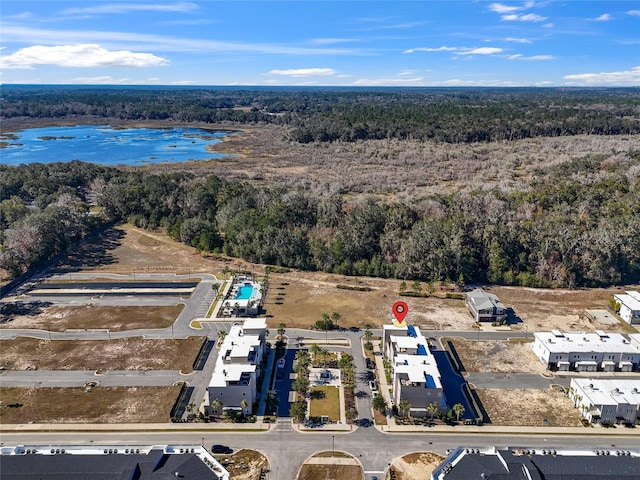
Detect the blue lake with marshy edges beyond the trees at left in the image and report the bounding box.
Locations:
[0,125,233,165]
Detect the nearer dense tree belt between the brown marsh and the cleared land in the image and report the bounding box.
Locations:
[0,158,640,287]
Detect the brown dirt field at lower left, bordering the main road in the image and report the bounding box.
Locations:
[0,386,180,424]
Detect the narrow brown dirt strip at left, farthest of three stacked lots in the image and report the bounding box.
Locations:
[0,305,184,332]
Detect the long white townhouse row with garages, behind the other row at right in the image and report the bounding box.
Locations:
[532,330,640,372]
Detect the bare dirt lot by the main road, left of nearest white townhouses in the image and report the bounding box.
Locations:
[477,389,581,427]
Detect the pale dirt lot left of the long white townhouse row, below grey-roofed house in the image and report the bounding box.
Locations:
[450,338,546,374]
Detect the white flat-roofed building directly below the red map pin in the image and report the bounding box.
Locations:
[383,325,448,417]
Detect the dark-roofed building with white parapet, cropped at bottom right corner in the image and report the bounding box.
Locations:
[431,447,640,480]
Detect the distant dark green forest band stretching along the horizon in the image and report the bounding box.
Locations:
[0,85,640,143]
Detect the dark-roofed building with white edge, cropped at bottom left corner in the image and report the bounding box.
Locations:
[0,445,230,480]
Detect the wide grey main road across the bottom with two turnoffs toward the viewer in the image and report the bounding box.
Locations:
[2,428,640,480]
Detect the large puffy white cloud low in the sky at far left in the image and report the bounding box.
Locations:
[0,43,168,69]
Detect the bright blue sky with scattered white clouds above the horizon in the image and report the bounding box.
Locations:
[0,0,640,86]
